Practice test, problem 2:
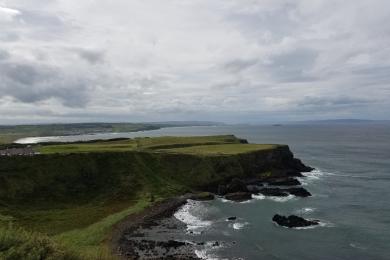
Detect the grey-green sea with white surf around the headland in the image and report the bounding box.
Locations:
[15,123,390,260]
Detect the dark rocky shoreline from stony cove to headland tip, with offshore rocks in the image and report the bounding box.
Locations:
[112,152,316,260]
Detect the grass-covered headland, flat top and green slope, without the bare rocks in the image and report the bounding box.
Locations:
[0,136,286,259]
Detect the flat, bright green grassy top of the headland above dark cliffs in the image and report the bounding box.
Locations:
[35,135,276,155]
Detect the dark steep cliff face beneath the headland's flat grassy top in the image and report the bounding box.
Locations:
[0,146,310,204]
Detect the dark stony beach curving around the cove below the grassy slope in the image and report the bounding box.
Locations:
[109,194,201,260]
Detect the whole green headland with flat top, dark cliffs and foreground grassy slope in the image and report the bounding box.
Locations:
[0,135,311,259]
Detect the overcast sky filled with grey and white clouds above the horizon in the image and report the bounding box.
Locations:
[0,0,390,124]
